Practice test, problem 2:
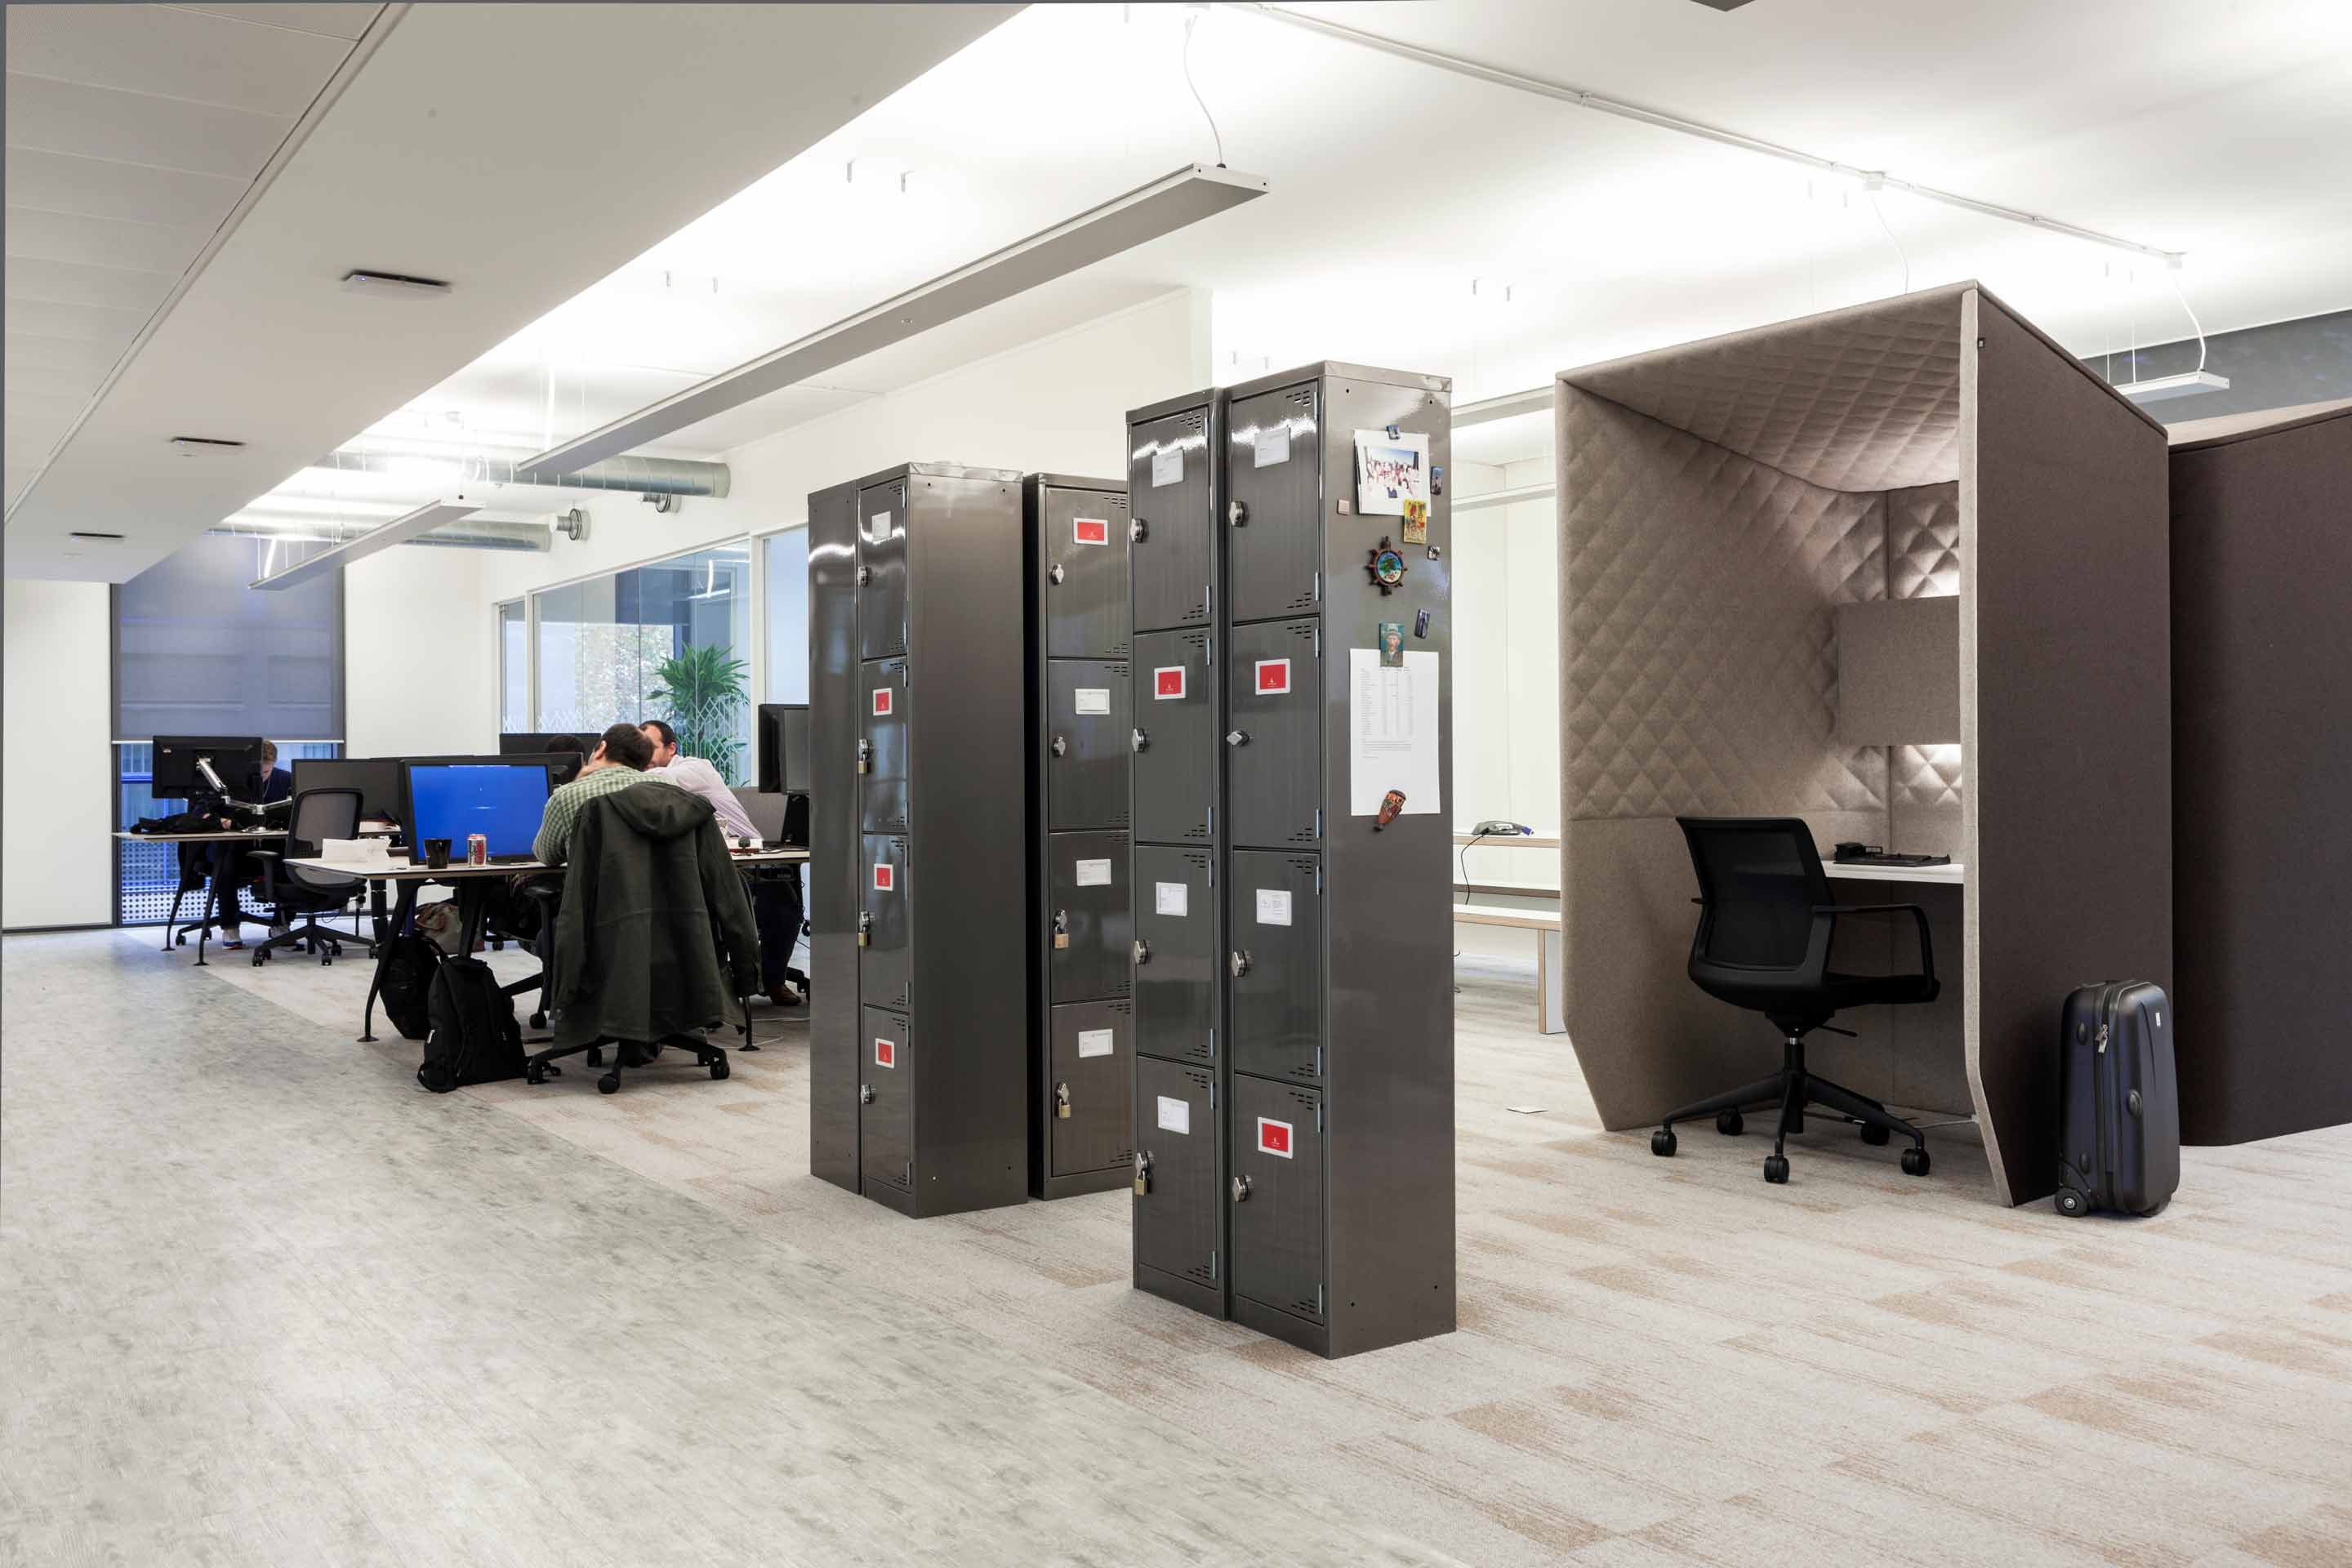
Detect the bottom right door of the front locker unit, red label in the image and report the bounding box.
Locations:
[1227,1075,1324,1321]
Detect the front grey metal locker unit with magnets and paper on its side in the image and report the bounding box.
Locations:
[1129,364,1454,1356]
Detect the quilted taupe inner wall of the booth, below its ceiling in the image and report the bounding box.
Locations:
[1561,388,1886,821]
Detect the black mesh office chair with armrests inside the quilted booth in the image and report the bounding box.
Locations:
[1649,816,1938,1183]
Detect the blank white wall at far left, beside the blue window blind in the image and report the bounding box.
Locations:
[0,581,115,931]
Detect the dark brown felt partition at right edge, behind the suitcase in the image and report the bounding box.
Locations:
[2171,407,2352,1143]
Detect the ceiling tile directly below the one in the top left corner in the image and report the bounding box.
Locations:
[7,70,296,181]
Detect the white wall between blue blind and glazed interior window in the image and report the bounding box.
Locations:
[343,538,491,757]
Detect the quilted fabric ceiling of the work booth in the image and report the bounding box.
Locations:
[1561,284,1971,492]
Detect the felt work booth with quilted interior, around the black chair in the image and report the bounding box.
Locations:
[1557,284,2171,1204]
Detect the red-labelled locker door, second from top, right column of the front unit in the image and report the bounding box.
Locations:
[1225,621,1324,849]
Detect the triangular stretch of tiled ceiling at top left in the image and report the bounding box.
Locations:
[5,5,383,503]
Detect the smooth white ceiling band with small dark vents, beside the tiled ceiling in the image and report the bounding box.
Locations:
[7,5,1016,581]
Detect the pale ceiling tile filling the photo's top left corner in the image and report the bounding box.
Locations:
[7,5,350,115]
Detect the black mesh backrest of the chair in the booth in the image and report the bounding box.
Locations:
[1675,816,1830,971]
